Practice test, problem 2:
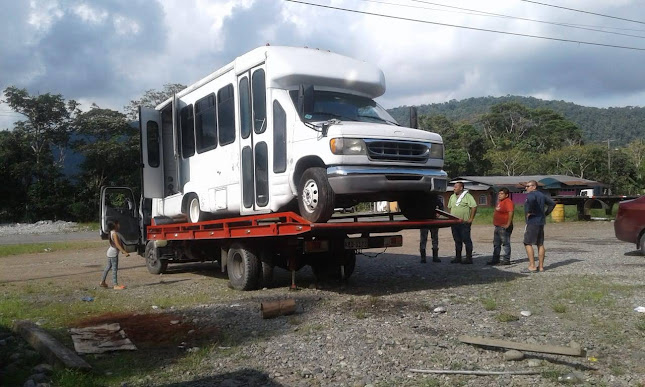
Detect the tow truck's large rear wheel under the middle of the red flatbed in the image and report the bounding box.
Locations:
[226,243,262,290]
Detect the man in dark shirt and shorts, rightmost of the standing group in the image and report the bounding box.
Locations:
[524,180,555,272]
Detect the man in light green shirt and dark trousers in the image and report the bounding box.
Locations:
[448,181,477,264]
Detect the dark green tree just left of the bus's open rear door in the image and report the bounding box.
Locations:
[70,105,140,220]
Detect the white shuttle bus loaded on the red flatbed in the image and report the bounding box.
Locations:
[139,46,447,222]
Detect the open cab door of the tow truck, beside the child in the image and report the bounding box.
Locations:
[100,187,141,252]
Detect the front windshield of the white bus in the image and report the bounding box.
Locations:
[290,90,398,125]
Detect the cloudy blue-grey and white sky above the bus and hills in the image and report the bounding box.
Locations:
[0,0,645,129]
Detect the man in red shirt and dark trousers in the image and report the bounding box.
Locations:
[486,188,515,265]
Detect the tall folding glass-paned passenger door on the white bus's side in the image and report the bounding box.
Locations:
[238,64,272,214]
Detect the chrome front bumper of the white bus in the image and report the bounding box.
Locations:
[327,166,448,195]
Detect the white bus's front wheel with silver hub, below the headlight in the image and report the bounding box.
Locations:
[298,167,334,223]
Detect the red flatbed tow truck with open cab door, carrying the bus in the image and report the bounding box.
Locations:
[100,187,461,290]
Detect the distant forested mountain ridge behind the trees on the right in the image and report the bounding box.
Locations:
[389,95,645,145]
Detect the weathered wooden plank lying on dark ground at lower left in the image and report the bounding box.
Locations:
[13,321,92,370]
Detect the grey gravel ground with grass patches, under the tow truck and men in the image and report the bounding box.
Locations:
[0,222,645,386]
